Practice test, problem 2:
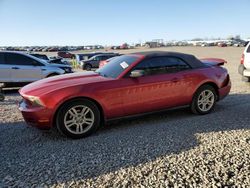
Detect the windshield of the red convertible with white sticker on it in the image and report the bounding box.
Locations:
[95,55,139,78]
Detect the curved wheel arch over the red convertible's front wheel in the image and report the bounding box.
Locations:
[52,96,105,127]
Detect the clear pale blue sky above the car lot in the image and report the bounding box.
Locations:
[0,0,250,46]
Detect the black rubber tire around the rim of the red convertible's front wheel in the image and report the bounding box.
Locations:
[56,99,101,139]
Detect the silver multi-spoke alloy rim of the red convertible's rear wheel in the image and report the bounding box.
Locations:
[198,90,215,112]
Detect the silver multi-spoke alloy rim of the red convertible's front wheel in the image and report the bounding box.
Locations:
[64,105,95,134]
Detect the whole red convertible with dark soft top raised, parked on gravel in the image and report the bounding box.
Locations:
[19,52,231,138]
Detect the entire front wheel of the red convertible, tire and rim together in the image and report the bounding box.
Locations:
[56,99,100,138]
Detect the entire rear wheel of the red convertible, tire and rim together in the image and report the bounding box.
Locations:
[191,85,217,115]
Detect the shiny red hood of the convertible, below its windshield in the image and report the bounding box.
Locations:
[19,71,111,97]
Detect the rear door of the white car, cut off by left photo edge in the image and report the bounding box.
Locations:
[0,53,11,83]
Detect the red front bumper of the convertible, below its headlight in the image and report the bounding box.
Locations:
[19,100,53,129]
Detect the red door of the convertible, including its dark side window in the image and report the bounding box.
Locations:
[121,57,190,115]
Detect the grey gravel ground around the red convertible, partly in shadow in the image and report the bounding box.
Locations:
[0,47,250,187]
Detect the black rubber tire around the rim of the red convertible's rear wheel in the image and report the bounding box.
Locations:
[191,85,218,115]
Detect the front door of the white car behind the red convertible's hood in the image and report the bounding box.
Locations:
[5,53,42,82]
